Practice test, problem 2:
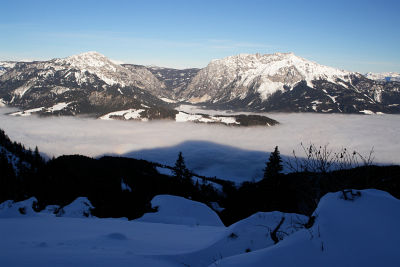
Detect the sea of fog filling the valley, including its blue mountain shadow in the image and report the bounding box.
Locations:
[0,107,400,182]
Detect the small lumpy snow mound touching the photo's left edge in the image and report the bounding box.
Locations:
[0,197,38,218]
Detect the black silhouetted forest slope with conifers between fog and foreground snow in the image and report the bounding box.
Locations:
[0,130,400,225]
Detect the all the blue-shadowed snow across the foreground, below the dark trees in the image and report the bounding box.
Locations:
[0,190,400,267]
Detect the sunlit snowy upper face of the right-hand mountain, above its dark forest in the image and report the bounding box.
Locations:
[184,53,351,103]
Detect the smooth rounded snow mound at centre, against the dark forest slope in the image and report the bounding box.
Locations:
[138,195,224,226]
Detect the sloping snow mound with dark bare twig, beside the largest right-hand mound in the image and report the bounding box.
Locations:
[167,211,308,267]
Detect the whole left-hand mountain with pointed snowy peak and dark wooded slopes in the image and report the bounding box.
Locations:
[0,52,177,119]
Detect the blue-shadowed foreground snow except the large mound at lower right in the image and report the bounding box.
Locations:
[0,195,305,266]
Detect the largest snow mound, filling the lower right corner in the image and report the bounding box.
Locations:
[214,189,400,267]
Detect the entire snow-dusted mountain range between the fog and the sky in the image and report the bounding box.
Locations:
[0,52,400,122]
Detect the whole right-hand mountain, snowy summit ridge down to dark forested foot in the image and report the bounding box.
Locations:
[180,53,400,113]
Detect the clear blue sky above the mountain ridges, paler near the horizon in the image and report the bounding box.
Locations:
[0,0,400,72]
